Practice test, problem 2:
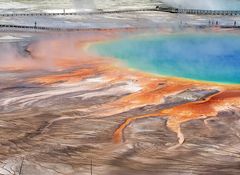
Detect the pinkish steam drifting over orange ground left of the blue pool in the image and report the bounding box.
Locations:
[0,31,109,70]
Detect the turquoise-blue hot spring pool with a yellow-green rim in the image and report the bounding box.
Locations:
[90,34,240,84]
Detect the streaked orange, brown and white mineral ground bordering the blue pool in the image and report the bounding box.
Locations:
[0,32,240,175]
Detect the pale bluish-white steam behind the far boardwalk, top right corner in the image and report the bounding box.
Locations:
[162,0,240,10]
